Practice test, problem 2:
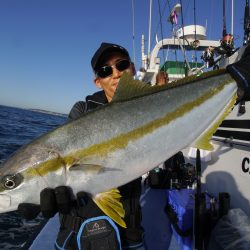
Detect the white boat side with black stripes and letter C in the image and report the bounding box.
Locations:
[183,102,250,216]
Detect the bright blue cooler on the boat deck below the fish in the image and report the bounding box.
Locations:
[166,189,195,250]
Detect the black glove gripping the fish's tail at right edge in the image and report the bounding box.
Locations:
[226,45,250,103]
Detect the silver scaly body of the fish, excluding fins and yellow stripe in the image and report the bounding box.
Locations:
[0,74,236,211]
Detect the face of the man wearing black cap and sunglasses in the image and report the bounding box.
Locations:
[94,52,135,102]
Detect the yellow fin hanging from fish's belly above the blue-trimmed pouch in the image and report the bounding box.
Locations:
[93,189,126,228]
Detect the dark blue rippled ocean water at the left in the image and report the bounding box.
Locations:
[0,105,67,250]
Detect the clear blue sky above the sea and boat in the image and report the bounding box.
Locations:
[0,0,245,113]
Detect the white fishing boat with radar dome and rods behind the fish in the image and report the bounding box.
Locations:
[141,1,250,249]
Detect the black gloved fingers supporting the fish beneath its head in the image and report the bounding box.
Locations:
[18,186,74,219]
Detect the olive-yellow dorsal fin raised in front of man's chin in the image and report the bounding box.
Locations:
[112,72,159,102]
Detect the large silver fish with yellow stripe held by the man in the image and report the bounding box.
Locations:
[0,70,237,227]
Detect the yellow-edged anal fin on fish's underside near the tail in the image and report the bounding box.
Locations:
[192,94,237,151]
